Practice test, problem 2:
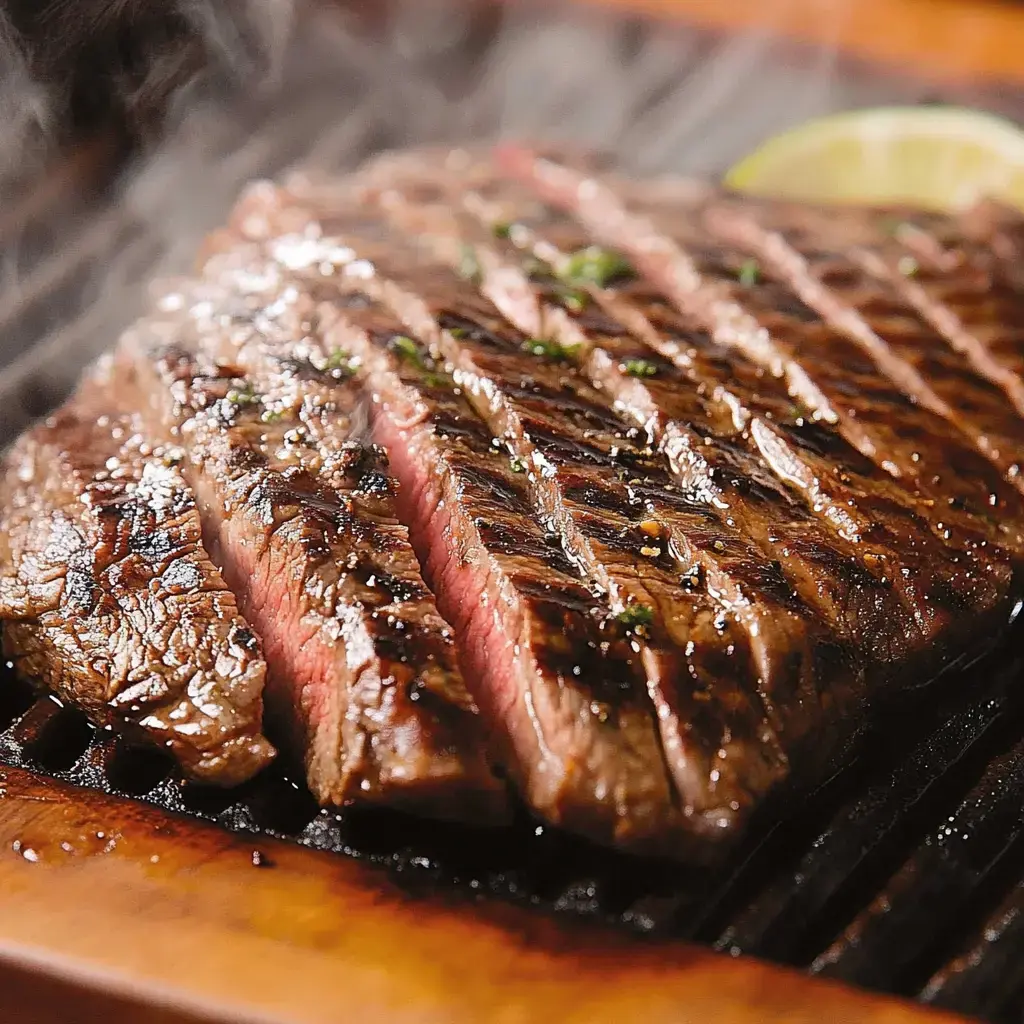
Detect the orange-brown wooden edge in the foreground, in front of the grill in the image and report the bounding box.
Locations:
[0,769,955,1024]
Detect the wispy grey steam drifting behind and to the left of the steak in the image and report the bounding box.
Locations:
[0,0,1011,431]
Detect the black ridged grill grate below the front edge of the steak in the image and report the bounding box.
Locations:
[6,629,1024,1024]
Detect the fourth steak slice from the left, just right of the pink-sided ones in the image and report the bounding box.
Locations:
[214,182,785,836]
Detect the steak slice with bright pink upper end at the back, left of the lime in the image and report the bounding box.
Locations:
[508,154,1021,532]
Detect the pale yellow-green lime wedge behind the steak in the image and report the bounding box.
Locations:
[725,106,1024,211]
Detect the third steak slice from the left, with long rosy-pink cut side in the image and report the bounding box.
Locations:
[195,232,703,856]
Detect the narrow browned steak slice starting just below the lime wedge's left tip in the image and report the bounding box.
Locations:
[706,205,1024,490]
